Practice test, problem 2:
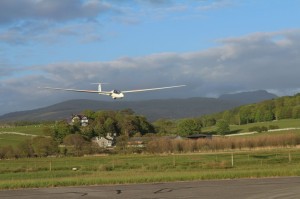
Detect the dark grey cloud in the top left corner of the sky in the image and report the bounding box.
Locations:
[0,0,111,24]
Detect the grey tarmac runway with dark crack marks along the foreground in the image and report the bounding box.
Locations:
[0,177,300,199]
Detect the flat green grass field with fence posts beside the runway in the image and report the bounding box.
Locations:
[0,148,300,189]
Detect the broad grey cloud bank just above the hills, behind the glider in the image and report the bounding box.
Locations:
[0,30,300,112]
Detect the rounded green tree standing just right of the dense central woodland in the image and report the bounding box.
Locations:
[177,119,201,136]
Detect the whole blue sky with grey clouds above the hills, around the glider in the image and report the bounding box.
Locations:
[0,0,300,115]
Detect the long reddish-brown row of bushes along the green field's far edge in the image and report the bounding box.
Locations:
[147,133,300,153]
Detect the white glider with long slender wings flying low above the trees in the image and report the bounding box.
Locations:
[40,83,186,99]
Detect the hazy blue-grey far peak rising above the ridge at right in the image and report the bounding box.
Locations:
[219,90,278,104]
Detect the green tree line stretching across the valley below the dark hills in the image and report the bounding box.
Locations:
[0,94,300,158]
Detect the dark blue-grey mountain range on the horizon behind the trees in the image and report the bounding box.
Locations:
[0,90,277,122]
